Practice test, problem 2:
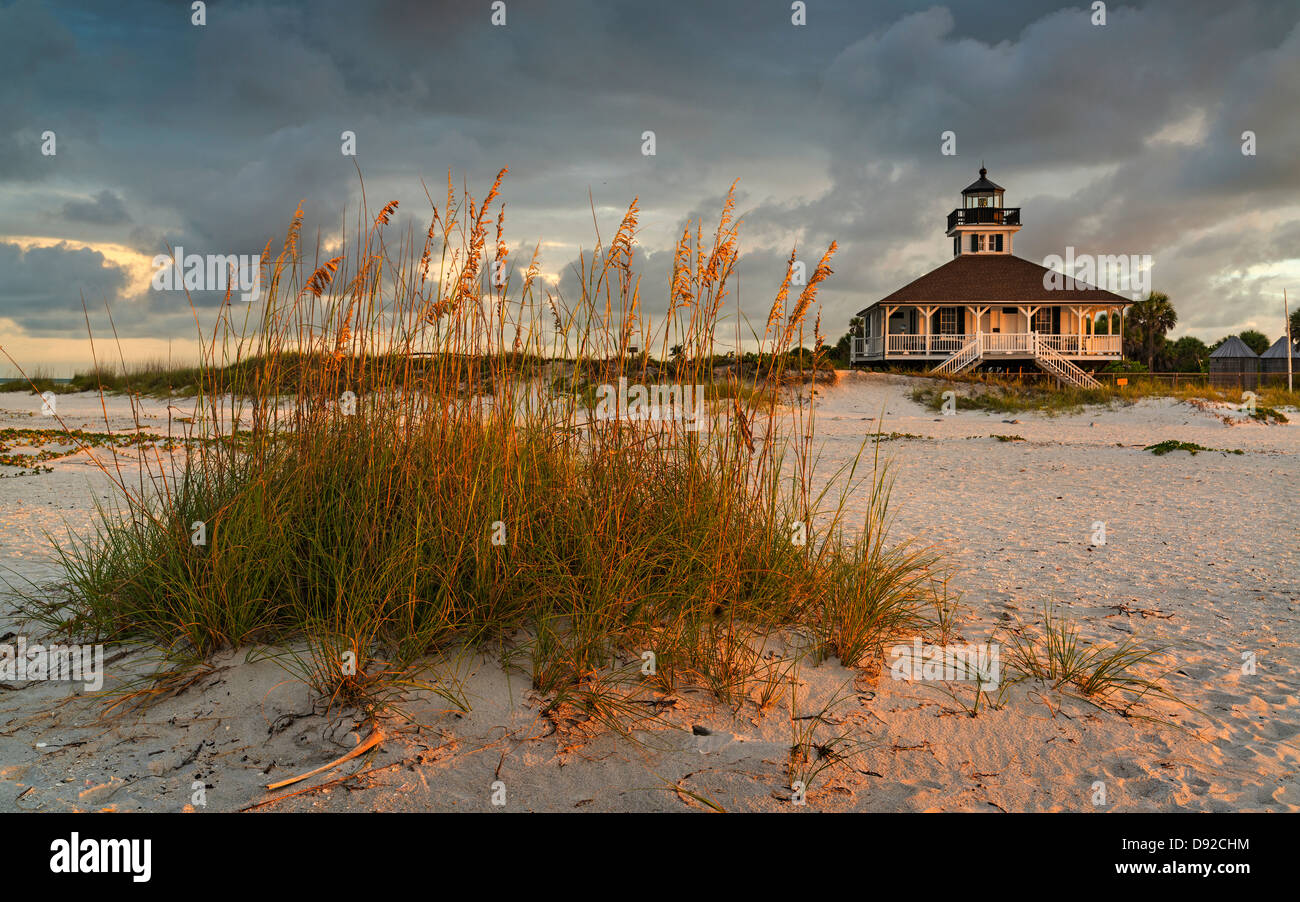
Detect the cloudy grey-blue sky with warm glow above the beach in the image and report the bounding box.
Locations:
[0,0,1300,376]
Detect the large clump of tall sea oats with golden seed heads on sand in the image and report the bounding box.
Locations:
[15,170,935,711]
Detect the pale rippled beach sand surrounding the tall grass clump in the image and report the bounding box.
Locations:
[0,373,1300,811]
